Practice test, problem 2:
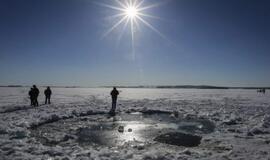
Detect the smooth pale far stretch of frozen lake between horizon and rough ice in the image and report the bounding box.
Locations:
[0,87,270,106]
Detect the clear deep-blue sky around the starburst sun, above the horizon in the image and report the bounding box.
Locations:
[0,0,270,86]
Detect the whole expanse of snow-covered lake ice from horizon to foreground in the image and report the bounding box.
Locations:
[0,87,270,160]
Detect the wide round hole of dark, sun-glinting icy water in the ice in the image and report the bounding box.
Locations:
[32,112,215,147]
